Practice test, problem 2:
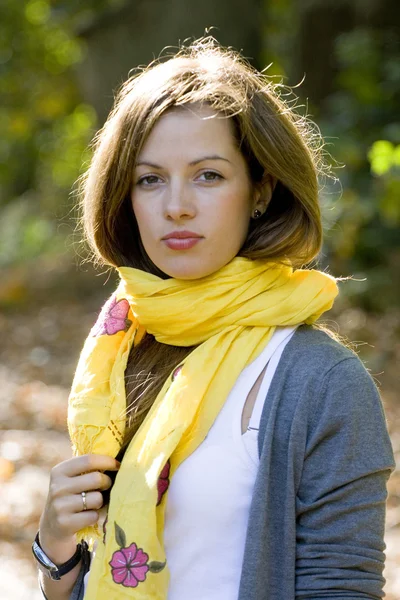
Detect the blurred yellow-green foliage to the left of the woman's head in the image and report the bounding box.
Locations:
[0,0,96,267]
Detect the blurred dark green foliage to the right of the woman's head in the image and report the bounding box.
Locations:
[320,27,400,311]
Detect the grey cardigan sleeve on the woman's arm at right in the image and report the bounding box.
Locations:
[296,356,395,600]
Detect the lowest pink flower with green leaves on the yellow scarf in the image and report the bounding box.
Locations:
[108,523,167,587]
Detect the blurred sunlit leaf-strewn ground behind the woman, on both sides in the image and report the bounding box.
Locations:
[0,276,400,600]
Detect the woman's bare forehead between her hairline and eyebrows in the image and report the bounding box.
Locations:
[138,105,238,160]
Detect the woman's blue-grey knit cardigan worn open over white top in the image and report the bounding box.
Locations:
[44,326,395,600]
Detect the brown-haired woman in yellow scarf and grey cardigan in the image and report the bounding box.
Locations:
[34,39,394,600]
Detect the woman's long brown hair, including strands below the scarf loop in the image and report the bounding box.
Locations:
[81,37,334,457]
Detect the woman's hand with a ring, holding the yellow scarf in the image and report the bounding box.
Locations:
[39,454,120,564]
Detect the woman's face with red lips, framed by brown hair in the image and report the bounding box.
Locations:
[131,107,262,279]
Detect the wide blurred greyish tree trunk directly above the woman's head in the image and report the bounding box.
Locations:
[78,0,264,123]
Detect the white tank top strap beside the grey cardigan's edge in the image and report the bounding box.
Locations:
[247,325,297,430]
